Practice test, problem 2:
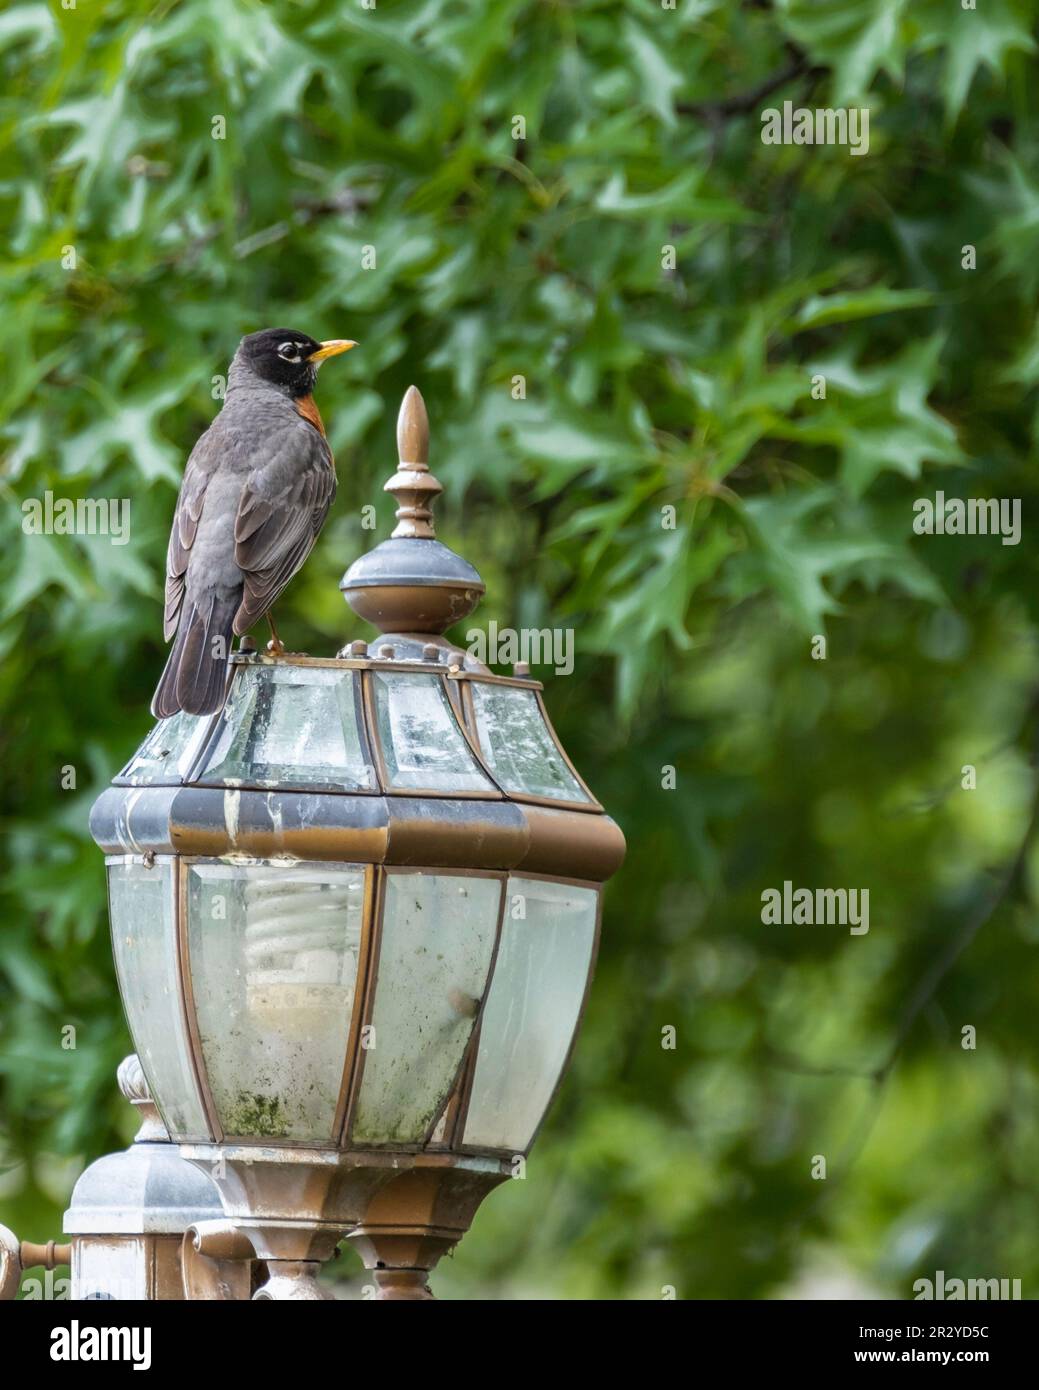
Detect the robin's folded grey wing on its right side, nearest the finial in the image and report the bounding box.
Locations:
[235,427,335,634]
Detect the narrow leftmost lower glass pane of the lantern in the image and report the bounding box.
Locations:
[108,859,210,1140]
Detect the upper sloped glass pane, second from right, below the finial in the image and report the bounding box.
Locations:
[371,671,494,792]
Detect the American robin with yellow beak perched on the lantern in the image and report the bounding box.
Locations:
[152,328,357,719]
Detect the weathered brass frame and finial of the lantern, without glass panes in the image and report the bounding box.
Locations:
[90,388,625,1298]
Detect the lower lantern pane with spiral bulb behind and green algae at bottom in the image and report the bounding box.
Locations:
[188,863,364,1141]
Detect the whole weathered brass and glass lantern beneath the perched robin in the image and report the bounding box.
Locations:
[90,386,625,1298]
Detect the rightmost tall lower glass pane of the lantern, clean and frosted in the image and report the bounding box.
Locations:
[462,878,598,1154]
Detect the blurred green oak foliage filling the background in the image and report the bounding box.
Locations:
[0,0,1039,1298]
